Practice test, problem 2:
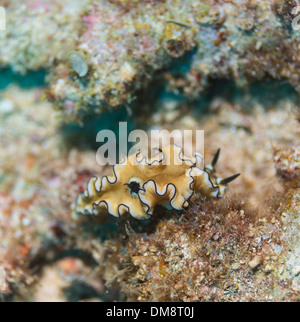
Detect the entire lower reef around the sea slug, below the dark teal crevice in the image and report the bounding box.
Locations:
[0,81,299,301]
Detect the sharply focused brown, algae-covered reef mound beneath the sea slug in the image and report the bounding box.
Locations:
[100,189,299,301]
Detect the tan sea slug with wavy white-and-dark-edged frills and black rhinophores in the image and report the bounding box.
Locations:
[76,145,239,219]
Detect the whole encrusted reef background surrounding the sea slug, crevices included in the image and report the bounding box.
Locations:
[0,0,300,301]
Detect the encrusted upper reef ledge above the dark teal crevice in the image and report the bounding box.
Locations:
[0,0,300,121]
